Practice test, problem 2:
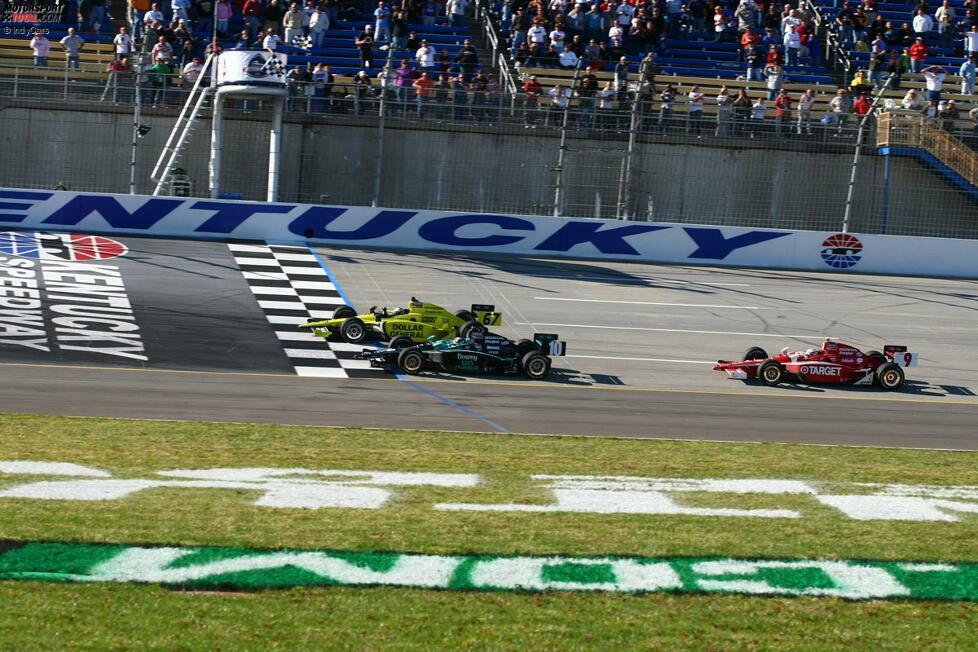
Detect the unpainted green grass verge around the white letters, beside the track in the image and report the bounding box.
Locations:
[0,415,978,649]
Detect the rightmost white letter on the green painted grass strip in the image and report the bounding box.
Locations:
[693,559,910,599]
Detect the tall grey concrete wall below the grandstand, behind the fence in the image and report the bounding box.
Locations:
[0,107,978,238]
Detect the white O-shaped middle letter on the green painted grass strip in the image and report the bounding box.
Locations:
[470,557,683,591]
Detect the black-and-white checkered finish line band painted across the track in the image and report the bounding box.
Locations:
[228,244,384,378]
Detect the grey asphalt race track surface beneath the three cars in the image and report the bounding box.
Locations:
[0,232,978,450]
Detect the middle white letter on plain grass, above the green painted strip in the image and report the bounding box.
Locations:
[435,476,800,518]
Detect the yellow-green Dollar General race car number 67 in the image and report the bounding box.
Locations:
[299,297,503,344]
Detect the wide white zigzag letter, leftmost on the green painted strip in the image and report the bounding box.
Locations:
[91,548,461,588]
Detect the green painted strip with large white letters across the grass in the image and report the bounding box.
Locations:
[0,541,978,601]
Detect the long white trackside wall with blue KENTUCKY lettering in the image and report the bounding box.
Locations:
[0,189,978,278]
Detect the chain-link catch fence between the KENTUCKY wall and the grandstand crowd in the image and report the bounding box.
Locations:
[0,64,978,238]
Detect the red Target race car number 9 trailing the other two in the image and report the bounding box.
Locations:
[713,339,917,391]
